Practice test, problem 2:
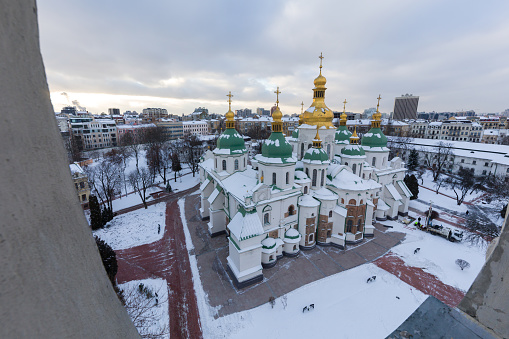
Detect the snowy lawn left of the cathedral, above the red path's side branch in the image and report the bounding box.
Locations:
[94,202,166,250]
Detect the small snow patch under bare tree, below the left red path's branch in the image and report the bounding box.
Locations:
[118,279,170,338]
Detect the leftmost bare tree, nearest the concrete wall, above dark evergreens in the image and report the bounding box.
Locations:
[85,157,121,211]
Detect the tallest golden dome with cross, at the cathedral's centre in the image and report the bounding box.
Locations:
[302,53,334,129]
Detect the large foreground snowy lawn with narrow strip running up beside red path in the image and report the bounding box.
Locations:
[179,199,427,339]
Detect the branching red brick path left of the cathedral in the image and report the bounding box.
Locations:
[116,198,203,339]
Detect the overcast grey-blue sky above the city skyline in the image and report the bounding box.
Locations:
[38,0,509,114]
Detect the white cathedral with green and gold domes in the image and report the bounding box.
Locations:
[196,65,411,288]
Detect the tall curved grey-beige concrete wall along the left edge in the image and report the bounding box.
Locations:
[0,0,138,338]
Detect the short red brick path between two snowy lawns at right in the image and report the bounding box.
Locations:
[374,252,465,307]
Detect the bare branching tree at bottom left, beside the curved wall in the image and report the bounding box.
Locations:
[121,284,169,339]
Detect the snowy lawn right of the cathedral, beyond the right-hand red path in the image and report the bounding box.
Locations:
[380,220,486,292]
